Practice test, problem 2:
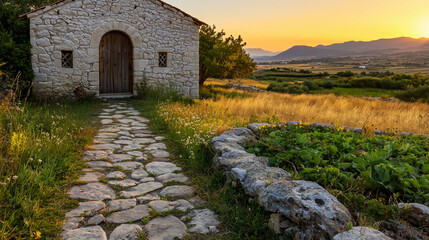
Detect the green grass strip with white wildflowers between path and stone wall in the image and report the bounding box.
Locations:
[134,97,278,240]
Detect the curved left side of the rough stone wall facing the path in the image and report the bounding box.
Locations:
[212,126,352,239]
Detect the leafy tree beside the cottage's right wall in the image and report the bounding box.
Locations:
[199,26,256,84]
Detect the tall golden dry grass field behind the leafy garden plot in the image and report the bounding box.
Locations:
[199,90,429,134]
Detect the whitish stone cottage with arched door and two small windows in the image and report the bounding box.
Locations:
[20,0,204,97]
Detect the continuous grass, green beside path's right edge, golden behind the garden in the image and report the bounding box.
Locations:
[134,84,429,239]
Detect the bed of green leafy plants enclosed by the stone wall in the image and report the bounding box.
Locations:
[247,124,429,222]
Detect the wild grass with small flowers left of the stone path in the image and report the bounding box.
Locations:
[0,92,101,239]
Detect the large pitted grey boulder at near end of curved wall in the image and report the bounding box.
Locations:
[259,181,352,239]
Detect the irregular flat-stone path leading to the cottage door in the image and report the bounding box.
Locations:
[63,103,219,240]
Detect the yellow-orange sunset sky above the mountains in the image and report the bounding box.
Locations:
[165,0,429,51]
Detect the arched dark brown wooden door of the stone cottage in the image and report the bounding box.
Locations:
[100,31,133,94]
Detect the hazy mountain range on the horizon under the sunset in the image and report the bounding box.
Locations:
[246,37,429,61]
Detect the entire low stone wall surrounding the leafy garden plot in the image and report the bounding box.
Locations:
[212,121,429,240]
